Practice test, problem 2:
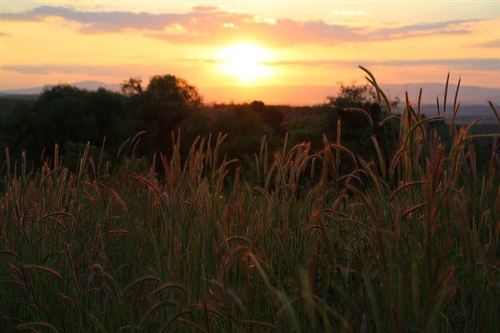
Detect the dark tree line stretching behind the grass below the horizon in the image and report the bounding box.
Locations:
[0,75,410,175]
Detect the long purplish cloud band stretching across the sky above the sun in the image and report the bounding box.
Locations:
[3,5,482,46]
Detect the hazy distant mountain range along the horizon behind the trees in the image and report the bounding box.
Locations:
[0,81,500,105]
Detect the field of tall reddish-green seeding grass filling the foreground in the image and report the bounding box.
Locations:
[0,71,500,332]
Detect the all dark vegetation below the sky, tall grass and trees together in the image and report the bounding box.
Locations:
[0,71,500,332]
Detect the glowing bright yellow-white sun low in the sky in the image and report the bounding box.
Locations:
[219,43,272,85]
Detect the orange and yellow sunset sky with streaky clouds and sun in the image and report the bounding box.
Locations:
[0,0,500,103]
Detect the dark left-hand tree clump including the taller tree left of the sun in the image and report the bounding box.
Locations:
[0,75,206,163]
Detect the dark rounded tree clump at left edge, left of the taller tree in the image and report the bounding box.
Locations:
[0,85,133,163]
